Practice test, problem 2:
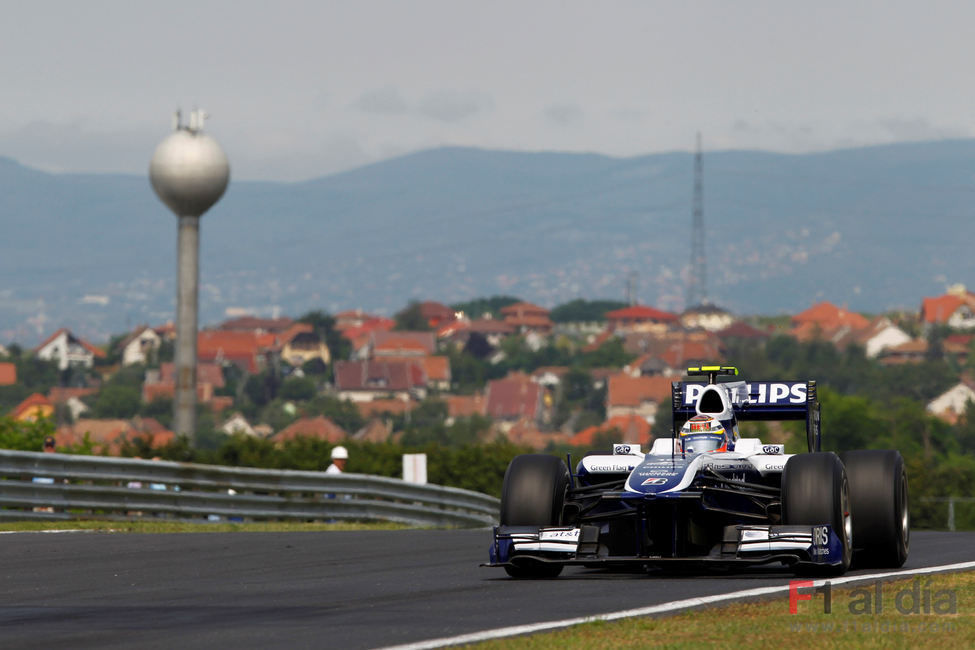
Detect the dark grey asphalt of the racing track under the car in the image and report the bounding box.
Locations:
[0,530,975,650]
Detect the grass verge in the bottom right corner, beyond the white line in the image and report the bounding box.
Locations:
[464,572,975,650]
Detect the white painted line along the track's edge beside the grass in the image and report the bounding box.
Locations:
[381,561,975,650]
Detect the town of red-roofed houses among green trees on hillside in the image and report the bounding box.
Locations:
[0,286,975,454]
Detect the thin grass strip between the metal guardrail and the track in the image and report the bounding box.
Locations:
[0,520,410,533]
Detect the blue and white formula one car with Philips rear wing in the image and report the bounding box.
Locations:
[486,366,910,578]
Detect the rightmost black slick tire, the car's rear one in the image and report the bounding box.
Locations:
[840,449,911,569]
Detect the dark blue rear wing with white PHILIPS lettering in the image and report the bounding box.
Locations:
[671,380,820,451]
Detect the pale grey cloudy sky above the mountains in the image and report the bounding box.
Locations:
[0,0,975,180]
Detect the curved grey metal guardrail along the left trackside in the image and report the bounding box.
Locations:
[0,450,499,527]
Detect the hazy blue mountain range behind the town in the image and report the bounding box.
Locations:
[0,140,975,345]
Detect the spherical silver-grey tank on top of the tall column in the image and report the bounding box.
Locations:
[149,128,230,217]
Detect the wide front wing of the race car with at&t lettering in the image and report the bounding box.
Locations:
[484,524,843,567]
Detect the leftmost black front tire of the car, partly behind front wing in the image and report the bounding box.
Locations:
[501,454,570,578]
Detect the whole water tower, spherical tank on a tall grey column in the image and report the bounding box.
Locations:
[149,110,230,439]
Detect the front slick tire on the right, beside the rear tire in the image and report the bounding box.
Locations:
[782,451,855,575]
